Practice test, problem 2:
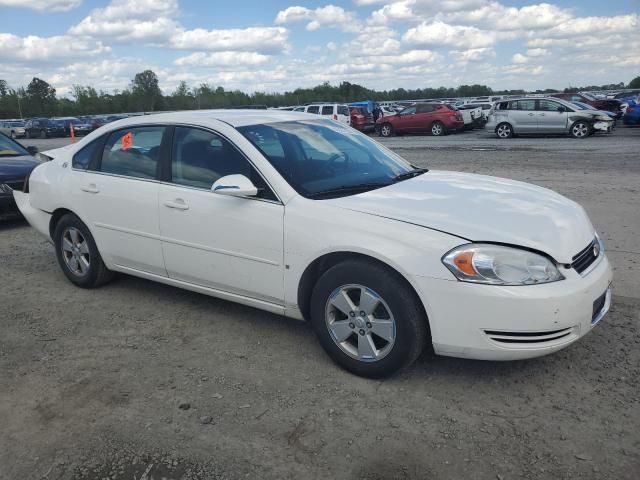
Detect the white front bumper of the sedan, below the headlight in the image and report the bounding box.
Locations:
[413,254,612,360]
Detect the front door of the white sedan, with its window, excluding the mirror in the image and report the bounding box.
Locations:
[159,127,284,303]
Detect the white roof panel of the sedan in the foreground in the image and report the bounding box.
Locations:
[108,110,323,127]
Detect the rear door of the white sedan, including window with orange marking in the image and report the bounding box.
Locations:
[72,125,167,276]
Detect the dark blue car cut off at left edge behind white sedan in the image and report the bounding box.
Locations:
[0,133,38,214]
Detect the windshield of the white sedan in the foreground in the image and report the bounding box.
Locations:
[238,121,414,198]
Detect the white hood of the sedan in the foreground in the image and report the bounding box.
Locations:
[326,171,595,263]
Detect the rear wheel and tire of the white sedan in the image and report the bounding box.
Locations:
[53,214,114,288]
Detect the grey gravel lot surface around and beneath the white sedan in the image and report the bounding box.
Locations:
[0,128,640,479]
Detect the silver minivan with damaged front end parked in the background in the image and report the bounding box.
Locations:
[485,97,613,138]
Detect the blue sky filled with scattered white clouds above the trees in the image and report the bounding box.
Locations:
[0,0,640,95]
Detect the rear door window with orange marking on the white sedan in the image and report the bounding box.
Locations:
[100,127,165,178]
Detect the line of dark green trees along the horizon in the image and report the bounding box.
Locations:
[0,70,640,118]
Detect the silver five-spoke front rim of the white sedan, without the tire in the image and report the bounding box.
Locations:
[325,284,396,362]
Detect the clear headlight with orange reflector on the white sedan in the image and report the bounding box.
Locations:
[442,243,564,285]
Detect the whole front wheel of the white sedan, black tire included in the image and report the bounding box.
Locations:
[311,259,429,378]
